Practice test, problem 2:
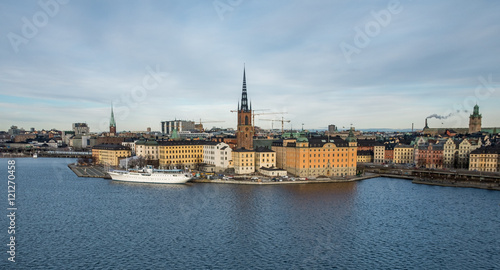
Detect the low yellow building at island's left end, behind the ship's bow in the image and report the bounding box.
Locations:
[92,144,132,166]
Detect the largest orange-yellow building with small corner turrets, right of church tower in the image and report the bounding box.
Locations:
[272,132,357,177]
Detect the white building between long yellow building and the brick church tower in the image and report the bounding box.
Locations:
[203,142,232,172]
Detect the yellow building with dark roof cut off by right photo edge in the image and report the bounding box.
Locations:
[469,146,500,172]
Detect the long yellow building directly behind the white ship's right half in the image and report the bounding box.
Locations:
[158,141,206,169]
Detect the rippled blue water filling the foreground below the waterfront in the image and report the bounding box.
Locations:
[0,158,500,269]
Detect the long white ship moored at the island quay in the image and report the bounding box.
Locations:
[108,166,192,184]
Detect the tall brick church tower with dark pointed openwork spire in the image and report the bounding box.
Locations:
[236,68,254,149]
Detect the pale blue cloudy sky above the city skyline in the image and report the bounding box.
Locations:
[0,0,500,132]
